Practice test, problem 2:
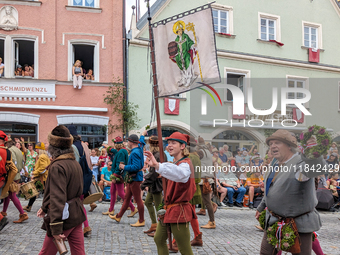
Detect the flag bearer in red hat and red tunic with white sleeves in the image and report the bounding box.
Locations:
[145,132,197,255]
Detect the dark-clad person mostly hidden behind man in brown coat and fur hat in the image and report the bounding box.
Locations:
[68,125,97,237]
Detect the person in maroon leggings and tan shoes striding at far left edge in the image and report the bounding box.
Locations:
[0,135,28,223]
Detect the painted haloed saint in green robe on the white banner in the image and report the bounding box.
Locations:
[168,20,198,87]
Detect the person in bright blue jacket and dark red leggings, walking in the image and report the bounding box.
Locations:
[103,136,135,217]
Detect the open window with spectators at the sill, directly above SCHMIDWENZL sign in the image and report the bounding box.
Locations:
[13,40,35,78]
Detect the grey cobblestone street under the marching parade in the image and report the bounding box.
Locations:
[0,199,340,255]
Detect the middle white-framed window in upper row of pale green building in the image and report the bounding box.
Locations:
[258,13,281,42]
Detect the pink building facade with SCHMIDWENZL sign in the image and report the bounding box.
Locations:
[0,0,124,148]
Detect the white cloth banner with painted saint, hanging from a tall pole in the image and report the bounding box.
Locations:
[153,5,220,97]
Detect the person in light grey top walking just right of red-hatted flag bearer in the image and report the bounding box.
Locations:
[197,138,218,228]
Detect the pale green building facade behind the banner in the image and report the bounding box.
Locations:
[129,0,340,154]
